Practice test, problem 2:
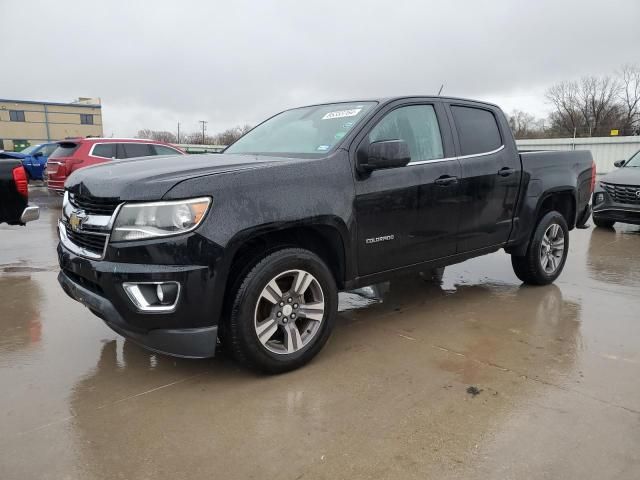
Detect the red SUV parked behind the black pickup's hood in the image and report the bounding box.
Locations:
[45,138,186,195]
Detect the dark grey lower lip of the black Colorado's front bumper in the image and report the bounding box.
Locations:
[58,271,218,358]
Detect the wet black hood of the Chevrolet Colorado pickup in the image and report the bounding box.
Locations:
[65,154,295,200]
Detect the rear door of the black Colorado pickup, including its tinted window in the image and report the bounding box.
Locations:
[449,104,521,253]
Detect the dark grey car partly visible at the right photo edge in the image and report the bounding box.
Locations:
[592,151,640,228]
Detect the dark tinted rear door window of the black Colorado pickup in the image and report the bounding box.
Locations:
[451,106,502,155]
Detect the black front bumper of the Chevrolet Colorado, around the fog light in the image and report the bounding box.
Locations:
[58,233,224,358]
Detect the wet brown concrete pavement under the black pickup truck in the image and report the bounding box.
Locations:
[0,189,640,480]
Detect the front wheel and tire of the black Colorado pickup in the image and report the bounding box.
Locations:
[225,248,338,374]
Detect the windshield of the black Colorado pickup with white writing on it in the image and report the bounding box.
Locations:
[224,102,375,157]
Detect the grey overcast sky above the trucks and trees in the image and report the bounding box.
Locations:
[0,0,640,136]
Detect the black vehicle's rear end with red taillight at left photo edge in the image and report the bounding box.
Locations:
[0,156,40,225]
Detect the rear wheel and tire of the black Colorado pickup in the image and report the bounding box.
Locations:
[511,211,569,285]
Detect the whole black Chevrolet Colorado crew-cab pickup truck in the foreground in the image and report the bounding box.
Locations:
[58,97,595,373]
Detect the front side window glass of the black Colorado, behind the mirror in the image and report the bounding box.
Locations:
[369,105,444,162]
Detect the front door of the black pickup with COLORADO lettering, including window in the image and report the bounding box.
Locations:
[355,103,460,276]
